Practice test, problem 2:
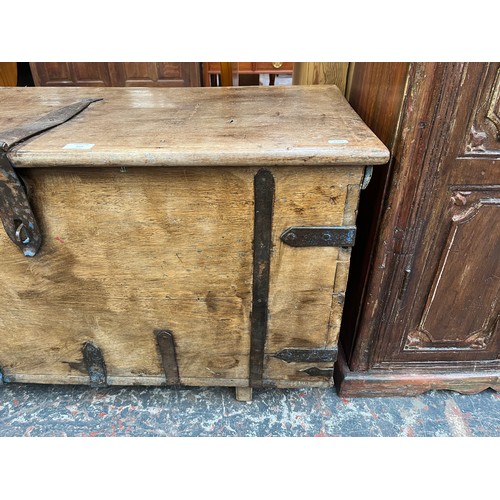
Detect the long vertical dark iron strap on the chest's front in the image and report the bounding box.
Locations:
[250,169,274,387]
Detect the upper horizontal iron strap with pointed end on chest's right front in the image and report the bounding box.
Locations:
[281,226,356,247]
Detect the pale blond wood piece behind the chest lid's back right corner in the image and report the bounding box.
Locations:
[292,62,349,94]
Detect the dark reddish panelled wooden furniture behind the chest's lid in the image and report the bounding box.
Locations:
[30,62,201,87]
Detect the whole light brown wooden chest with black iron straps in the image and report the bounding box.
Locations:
[0,86,389,399]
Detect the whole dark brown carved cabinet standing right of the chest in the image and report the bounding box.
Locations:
[337,63,500,396]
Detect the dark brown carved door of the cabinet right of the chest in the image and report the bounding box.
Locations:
[375,63,500,367]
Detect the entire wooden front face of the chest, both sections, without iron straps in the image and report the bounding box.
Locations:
[0,166,363,387]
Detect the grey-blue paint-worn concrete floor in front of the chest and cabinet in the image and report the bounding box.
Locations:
[0,384,500,437]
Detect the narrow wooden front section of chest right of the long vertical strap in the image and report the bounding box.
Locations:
[264,167,363,381]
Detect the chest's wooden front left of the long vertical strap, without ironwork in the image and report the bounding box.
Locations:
[0,169,254,383]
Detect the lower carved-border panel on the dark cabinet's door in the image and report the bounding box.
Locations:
[404,190,500,358]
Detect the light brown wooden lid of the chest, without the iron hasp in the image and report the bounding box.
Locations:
[0,85,389,168]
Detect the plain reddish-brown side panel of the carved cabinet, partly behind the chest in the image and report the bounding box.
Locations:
[340,62,409,363]
